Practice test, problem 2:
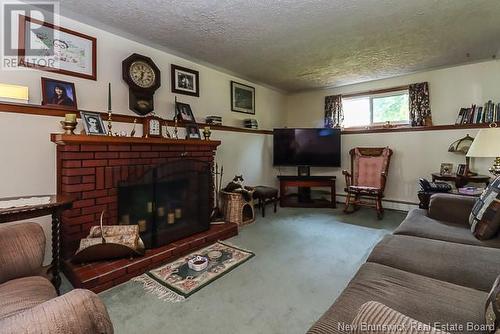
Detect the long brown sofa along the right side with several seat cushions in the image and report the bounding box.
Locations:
[308,194,500,334]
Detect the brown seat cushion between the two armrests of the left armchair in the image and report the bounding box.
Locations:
[0,276,57,319]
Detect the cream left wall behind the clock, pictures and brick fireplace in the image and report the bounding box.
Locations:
[0,13,286,264]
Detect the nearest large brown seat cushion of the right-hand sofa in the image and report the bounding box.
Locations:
[308,262,488,334]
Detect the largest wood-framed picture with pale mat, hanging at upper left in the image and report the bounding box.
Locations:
[18,15,97,80]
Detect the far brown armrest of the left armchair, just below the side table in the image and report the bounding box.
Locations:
[0,223,45,284]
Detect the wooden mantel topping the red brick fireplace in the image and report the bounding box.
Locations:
[50,133,221,146]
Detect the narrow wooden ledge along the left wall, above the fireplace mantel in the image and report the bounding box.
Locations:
[0,102,273,135]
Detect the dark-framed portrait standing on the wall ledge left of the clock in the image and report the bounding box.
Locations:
[42,78,78,110]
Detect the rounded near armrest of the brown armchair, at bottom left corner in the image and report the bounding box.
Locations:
[0,289,113,334]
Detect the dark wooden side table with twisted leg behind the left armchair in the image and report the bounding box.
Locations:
[0,195,73,293]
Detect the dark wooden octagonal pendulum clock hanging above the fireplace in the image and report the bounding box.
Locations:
[122,53,161,116]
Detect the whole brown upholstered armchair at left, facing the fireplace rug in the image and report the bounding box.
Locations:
[0,223,113,334]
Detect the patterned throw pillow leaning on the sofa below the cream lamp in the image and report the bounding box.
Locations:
[469,176,500,240]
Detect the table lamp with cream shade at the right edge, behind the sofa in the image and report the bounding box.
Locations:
[467,127,500,176]
